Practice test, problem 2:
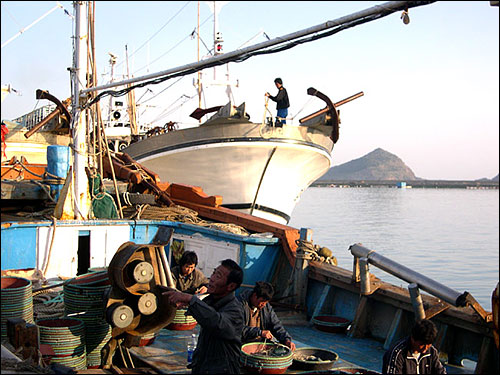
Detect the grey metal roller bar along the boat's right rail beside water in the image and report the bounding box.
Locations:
[349,244,466,306]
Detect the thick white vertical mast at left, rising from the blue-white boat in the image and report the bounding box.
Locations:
[71,1,90,220]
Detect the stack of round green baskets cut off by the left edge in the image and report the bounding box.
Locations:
[1,276,34,340]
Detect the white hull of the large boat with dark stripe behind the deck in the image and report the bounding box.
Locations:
[124,121,333,224]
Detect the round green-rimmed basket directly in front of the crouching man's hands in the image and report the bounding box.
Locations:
[240,342,293,374]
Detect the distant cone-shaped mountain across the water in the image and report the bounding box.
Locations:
[317,148,419,181]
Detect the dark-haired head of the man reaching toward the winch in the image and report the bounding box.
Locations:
[207,259,243,298]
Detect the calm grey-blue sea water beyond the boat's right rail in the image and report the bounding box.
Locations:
[289,187,499,311]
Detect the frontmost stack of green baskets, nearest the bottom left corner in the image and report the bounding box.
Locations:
[36,317,87,370]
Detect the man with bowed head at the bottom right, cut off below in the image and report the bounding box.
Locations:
[382,319,446,374]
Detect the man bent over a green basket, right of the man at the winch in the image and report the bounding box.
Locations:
[238,281,295,350]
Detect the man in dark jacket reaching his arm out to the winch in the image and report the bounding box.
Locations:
[163,259,243,374]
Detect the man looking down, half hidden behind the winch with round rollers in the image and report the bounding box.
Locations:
[172,251,208,294]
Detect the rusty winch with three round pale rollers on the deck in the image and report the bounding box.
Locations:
[102,226,176,368]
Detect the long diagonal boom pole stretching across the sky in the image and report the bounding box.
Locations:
[82,1,431,94]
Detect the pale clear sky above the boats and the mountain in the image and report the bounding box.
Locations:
[1,1,499,180]
